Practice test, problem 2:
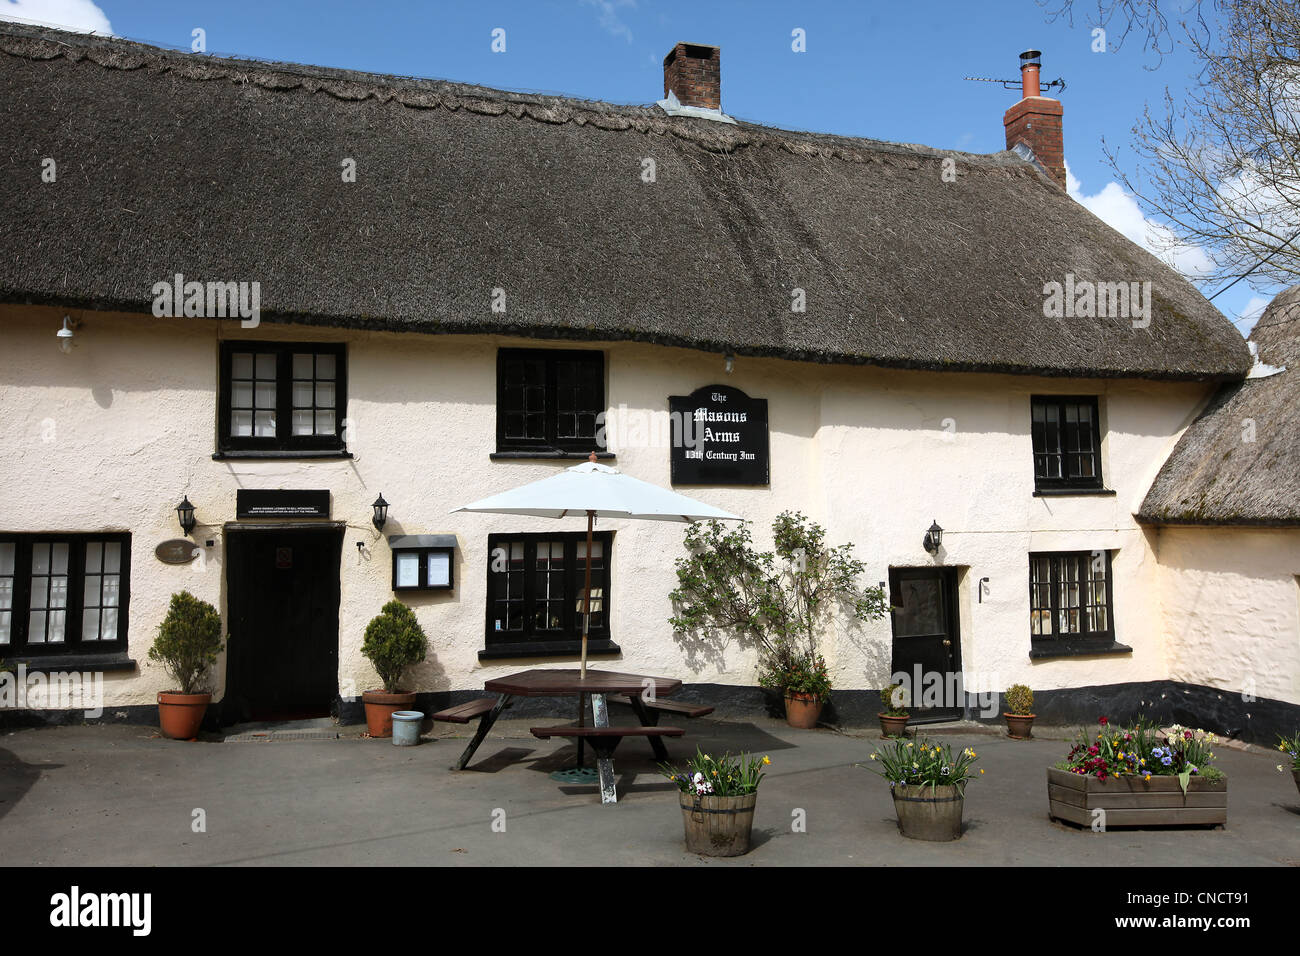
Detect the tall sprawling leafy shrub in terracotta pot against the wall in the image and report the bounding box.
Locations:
[670,511,889,727]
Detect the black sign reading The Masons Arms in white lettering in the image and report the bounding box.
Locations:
[668,385,768,485]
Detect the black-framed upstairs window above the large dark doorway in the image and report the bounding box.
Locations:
[217,342,347,454]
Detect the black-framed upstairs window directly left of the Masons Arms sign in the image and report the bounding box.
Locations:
[497,349,605,455]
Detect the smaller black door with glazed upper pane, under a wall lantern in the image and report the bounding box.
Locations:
[889,567,966,723]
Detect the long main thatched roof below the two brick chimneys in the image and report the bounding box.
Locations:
[0,23,1249,380]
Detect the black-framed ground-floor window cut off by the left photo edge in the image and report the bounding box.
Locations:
[0,535,131,659]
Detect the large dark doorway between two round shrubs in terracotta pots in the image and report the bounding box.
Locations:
[222,528,343,723]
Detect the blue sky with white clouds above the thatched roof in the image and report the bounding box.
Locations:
[0,0,1277,332]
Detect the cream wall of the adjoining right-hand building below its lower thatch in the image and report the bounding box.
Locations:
[1152,527,1300,704]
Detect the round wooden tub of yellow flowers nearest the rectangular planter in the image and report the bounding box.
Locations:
[867,737,984,843]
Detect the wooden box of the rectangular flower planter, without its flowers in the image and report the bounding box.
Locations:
[1048,767,1227,830]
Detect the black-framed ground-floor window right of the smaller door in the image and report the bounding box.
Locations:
[1030,551,1115,643]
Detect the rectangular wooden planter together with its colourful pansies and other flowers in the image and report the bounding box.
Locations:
[1048,717,1227,830]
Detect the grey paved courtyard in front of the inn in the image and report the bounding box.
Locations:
[0,718,1300,866]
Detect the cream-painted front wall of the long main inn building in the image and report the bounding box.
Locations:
[0,307,1227,706]
